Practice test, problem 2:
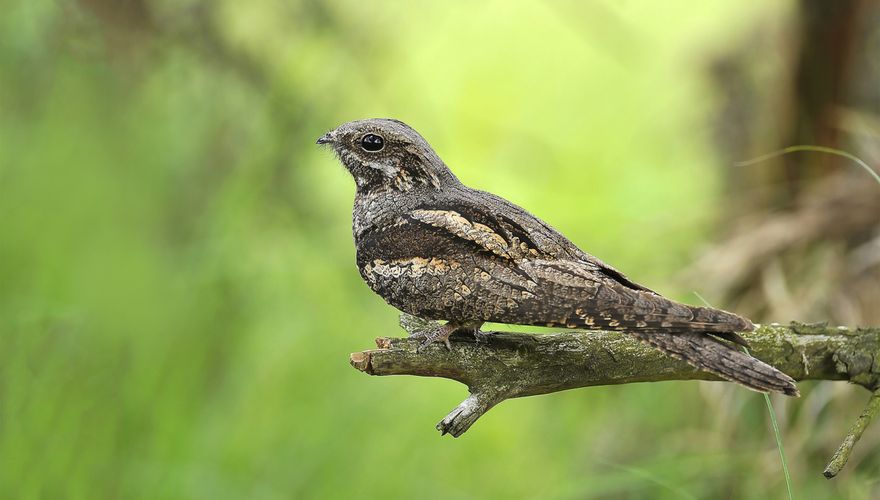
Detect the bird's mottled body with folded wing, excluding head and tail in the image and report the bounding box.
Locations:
[356,184,752,338]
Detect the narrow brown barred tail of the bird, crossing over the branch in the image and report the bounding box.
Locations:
[627,330,800,396]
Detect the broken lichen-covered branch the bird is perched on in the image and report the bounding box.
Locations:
[351,318,880,477]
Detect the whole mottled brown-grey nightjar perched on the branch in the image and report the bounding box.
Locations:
[316,118,799,396]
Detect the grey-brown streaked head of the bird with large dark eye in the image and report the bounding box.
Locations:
[317,118,457,191]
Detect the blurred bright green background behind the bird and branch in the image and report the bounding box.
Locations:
[0,0,880,499]
